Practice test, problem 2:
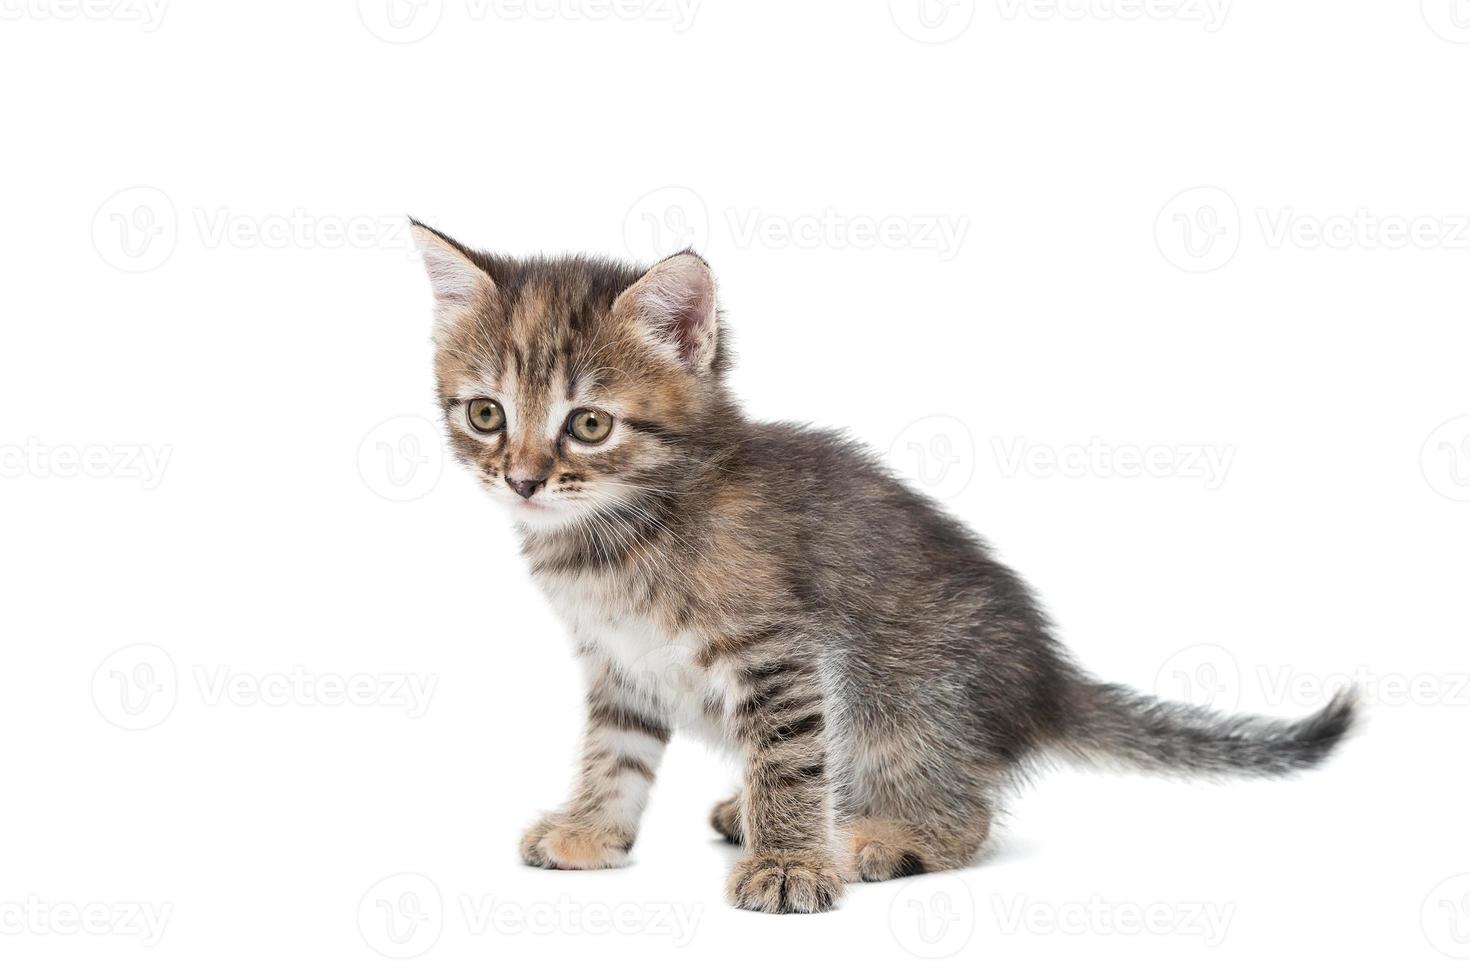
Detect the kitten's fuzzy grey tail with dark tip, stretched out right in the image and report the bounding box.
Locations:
[1060,679,1358,776]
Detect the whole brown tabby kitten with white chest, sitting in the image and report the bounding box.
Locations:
[413,222,1354,912]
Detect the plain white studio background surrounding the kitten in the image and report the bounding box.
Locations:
[0,0,1470,977]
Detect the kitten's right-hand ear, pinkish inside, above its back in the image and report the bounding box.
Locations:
[613,251,719,373]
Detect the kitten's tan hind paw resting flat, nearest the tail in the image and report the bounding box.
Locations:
[842,804,991,882]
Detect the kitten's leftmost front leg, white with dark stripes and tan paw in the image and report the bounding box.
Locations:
[520,667,669,868]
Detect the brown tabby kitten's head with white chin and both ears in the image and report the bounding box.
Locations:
[413,222,728,530]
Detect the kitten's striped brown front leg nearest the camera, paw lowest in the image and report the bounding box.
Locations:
[726,646,844,912]
